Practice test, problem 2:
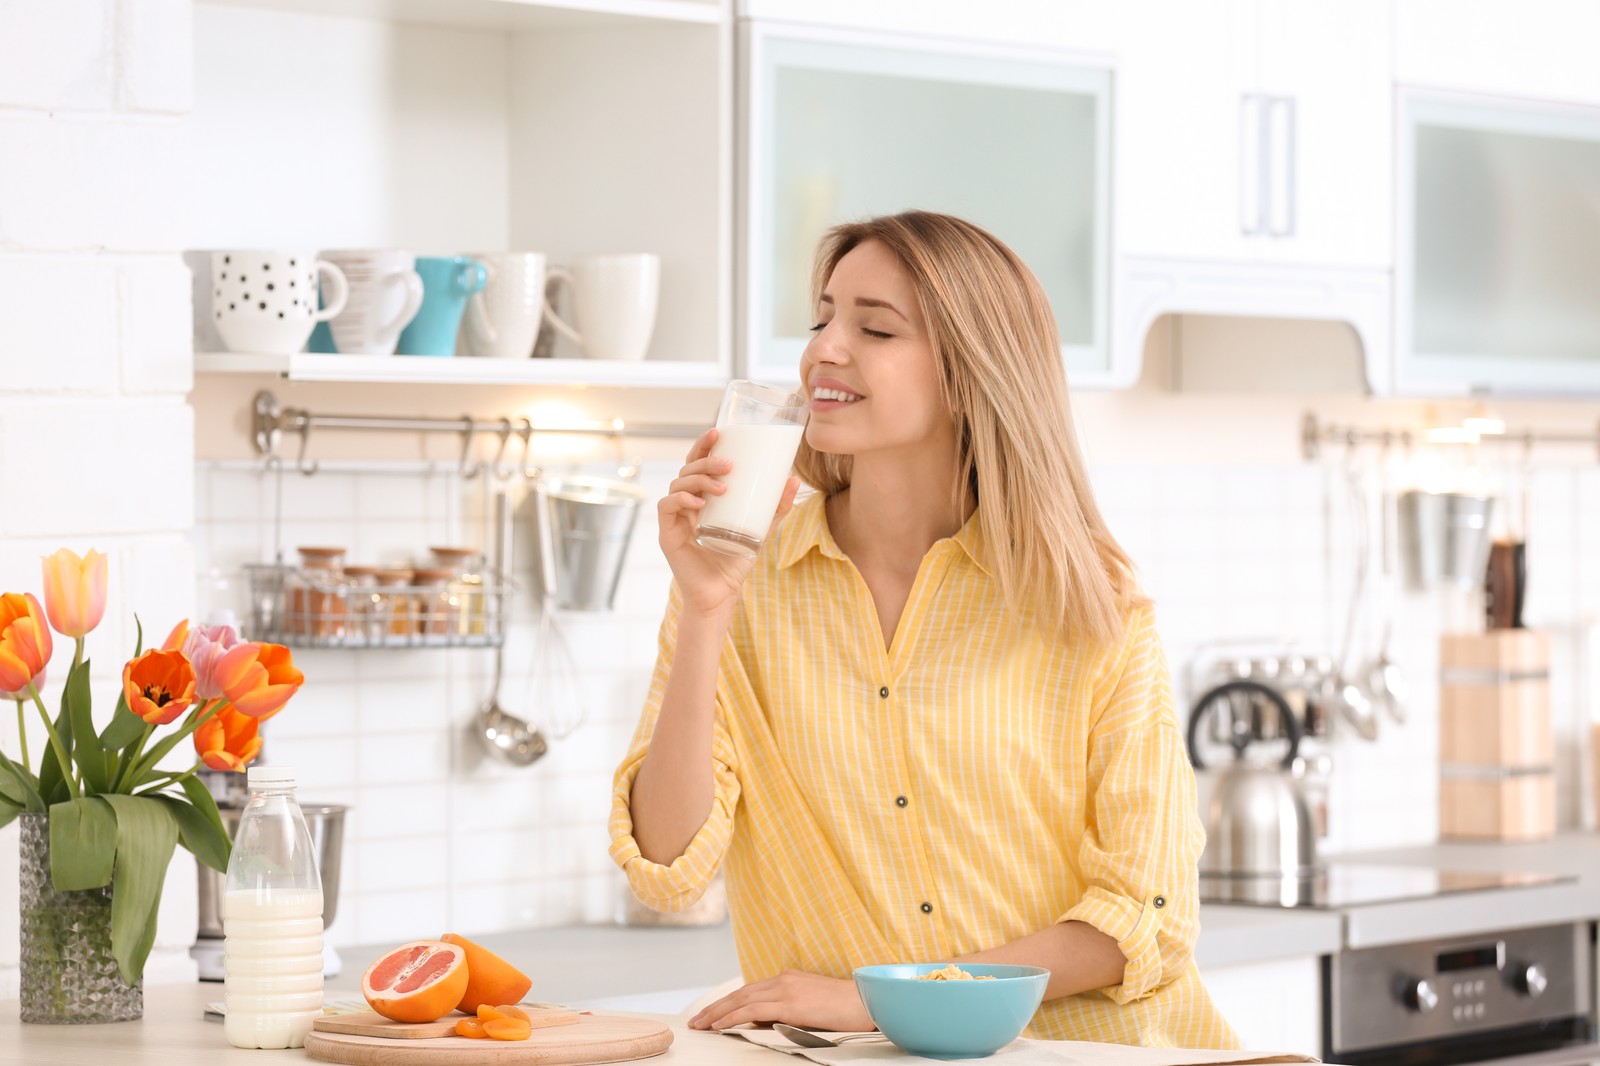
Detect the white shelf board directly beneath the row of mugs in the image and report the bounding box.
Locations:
[195,352,728,389]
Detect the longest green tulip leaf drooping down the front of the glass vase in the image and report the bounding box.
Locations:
[99,794,178,984]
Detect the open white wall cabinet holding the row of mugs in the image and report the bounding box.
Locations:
[187,0,733,386]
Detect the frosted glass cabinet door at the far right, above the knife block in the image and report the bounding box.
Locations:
[1395,93,1600,394]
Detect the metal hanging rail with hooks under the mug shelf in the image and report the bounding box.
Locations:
[253,389,706,477]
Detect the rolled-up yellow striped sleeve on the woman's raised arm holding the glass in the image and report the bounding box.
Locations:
[610,583,739,911]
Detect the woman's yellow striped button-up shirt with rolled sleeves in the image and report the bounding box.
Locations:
[611,495,1237,1047]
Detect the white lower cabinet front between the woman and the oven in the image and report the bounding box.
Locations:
[1200,956,1322,1056]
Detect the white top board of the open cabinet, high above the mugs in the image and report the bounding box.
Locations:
[203,0,722,30]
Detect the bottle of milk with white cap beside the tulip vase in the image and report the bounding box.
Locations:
[222,767,322,1048]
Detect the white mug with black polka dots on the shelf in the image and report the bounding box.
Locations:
[211,250,350,355]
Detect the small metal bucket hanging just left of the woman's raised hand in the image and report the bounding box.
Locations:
[534,477,646,611]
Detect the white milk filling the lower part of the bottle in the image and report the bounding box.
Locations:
[222,888,322,1048]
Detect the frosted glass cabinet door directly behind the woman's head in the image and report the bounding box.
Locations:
[739,22,1110,384]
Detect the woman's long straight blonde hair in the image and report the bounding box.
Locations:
[795,211,1146,642]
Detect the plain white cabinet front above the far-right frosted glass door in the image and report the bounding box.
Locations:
[1394,0,1600,104]
